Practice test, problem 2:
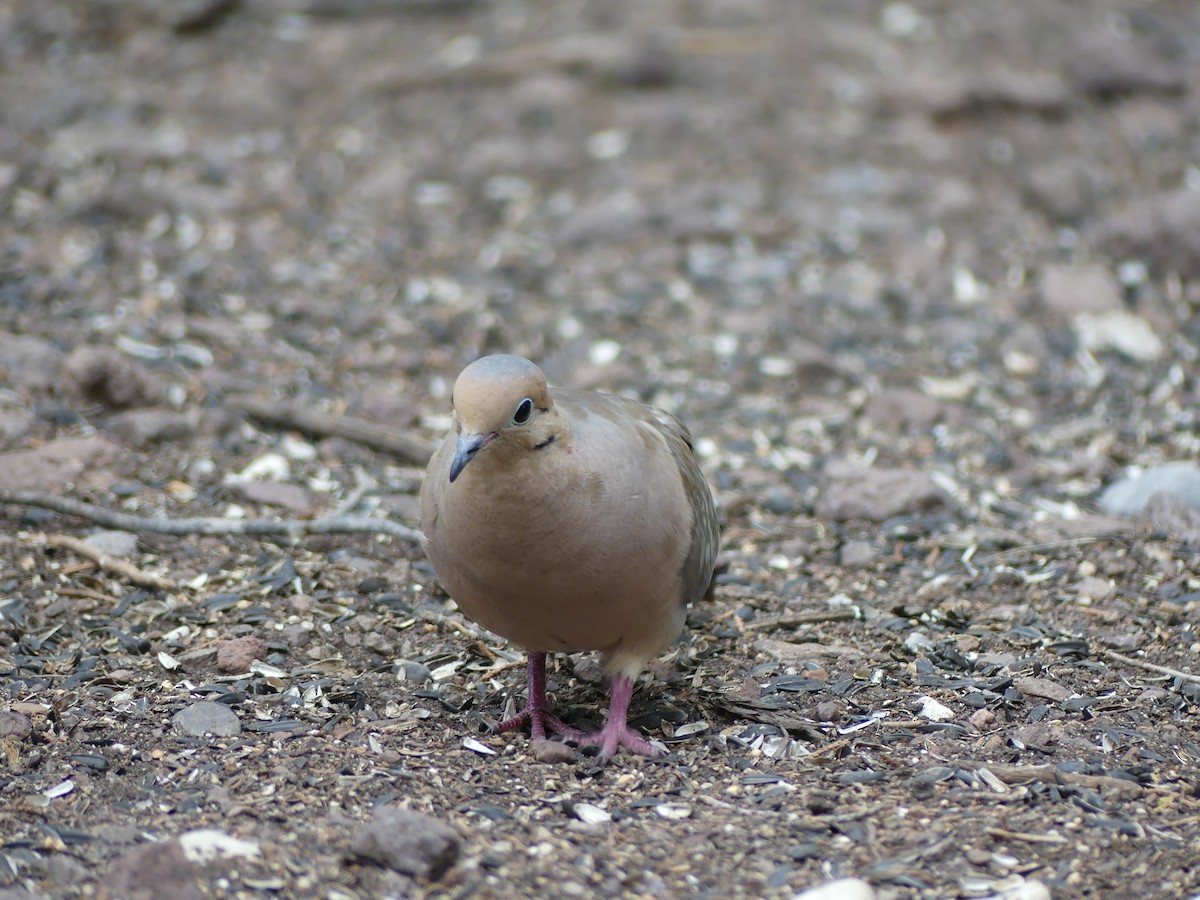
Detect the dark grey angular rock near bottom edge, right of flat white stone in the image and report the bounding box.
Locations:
[350,806,462,880]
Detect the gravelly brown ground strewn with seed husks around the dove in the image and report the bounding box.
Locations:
[0,0,1200,898]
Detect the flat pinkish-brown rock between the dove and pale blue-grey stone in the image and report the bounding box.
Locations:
[816,466,949,522]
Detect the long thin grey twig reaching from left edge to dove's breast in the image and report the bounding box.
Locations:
[0,490,421,544]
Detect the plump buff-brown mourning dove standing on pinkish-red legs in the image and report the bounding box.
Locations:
[421,355,720,760]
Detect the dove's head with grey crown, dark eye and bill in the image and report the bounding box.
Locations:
[450,354,556,481]
